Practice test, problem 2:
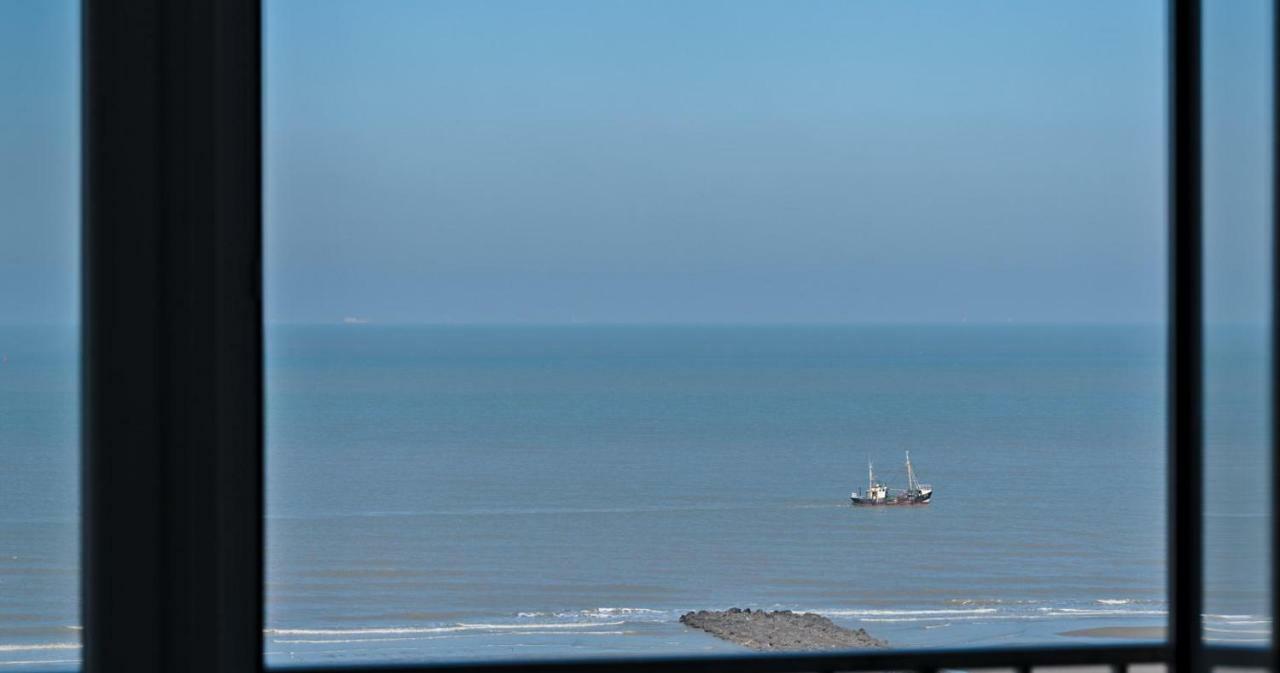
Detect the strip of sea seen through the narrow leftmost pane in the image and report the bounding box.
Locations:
[0,325,79,670]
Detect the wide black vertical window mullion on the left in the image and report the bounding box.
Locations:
[82,0,262,673]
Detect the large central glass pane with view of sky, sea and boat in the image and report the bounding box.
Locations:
[265,0,1166,664]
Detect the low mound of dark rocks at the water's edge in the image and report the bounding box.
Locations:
[680,608,888,651]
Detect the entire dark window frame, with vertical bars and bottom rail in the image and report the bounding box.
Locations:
[82,0,1280,673]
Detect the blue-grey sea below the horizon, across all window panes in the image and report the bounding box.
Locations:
[0,324,1271,670]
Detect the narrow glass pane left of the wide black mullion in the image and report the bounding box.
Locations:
[0,0,79,670]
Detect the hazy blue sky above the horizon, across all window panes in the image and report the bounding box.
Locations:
[0,0,1270,322]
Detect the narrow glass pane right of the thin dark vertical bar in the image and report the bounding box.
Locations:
[1203,0,1272,646]
